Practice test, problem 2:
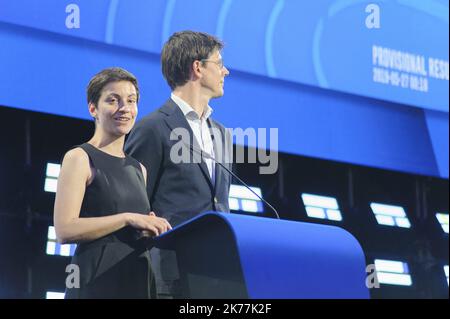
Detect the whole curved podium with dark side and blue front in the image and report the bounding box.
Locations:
[153,212,369,299]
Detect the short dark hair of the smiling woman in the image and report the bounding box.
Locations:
[87,67,139,107]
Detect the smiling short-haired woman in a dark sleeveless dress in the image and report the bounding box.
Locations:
[54,68,171,298]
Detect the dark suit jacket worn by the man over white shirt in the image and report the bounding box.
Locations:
[125,99,232,297]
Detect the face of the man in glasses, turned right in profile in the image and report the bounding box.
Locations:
[201,50,230,98]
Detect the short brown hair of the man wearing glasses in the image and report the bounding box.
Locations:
[161,31,223,90]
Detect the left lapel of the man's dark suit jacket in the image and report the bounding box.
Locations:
[160,99,213,189]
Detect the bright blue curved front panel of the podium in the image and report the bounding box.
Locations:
[221,214,369,298]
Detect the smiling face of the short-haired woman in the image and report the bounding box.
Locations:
[89,81,137,137]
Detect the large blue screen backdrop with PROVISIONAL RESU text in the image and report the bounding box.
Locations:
[0,0,449,178]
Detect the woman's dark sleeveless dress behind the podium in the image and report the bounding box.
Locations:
[66,143,156,298]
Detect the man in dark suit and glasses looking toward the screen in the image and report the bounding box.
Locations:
[125,31,231,298]
